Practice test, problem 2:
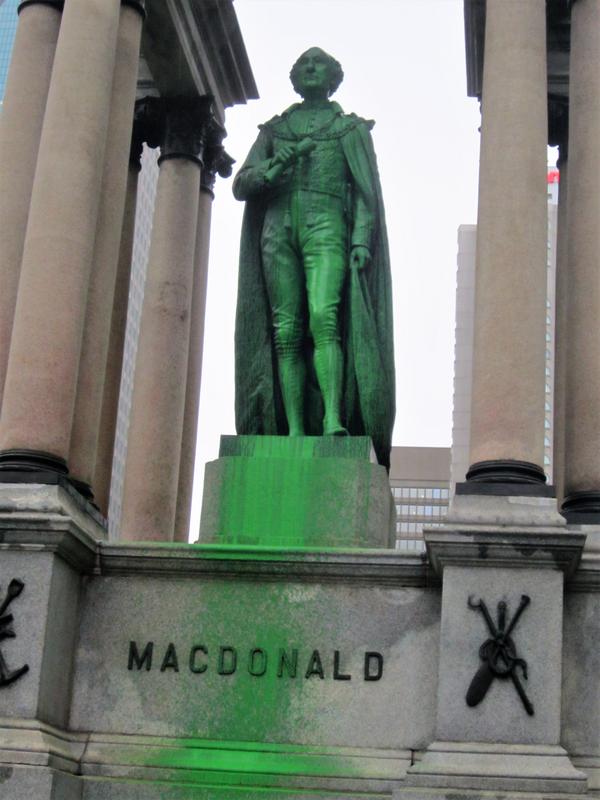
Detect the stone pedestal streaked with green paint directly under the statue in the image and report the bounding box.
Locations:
[200,436,396,548]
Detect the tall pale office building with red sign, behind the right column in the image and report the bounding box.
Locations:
[450,168,559,492]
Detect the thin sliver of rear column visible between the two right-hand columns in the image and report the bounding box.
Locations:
[551,107,569,504]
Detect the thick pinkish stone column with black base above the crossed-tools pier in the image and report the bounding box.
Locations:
[467,0,548,493]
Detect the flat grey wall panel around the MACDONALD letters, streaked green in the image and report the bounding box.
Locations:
[70,564,439,749]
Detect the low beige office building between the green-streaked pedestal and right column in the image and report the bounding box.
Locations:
[390,447,450,550]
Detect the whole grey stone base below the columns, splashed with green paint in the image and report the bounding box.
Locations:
[0,487,600,800]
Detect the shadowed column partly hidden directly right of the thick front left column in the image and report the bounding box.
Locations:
[69,0,145,497]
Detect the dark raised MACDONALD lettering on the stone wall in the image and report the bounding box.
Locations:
[127,641,383,681]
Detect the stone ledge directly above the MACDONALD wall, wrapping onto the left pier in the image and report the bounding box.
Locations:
[0,528,432,587]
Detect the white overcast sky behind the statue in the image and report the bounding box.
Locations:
[190,0,480,541]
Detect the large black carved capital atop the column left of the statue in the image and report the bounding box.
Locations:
[136,94,221,167]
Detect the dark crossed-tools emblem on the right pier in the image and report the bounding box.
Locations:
[467,594,534,716]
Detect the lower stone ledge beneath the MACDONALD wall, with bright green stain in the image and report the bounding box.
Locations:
[0,718,412,798]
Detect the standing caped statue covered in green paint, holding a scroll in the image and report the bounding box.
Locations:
[233,47,395,466]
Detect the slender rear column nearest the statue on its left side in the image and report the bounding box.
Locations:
[175,144,233,542]
